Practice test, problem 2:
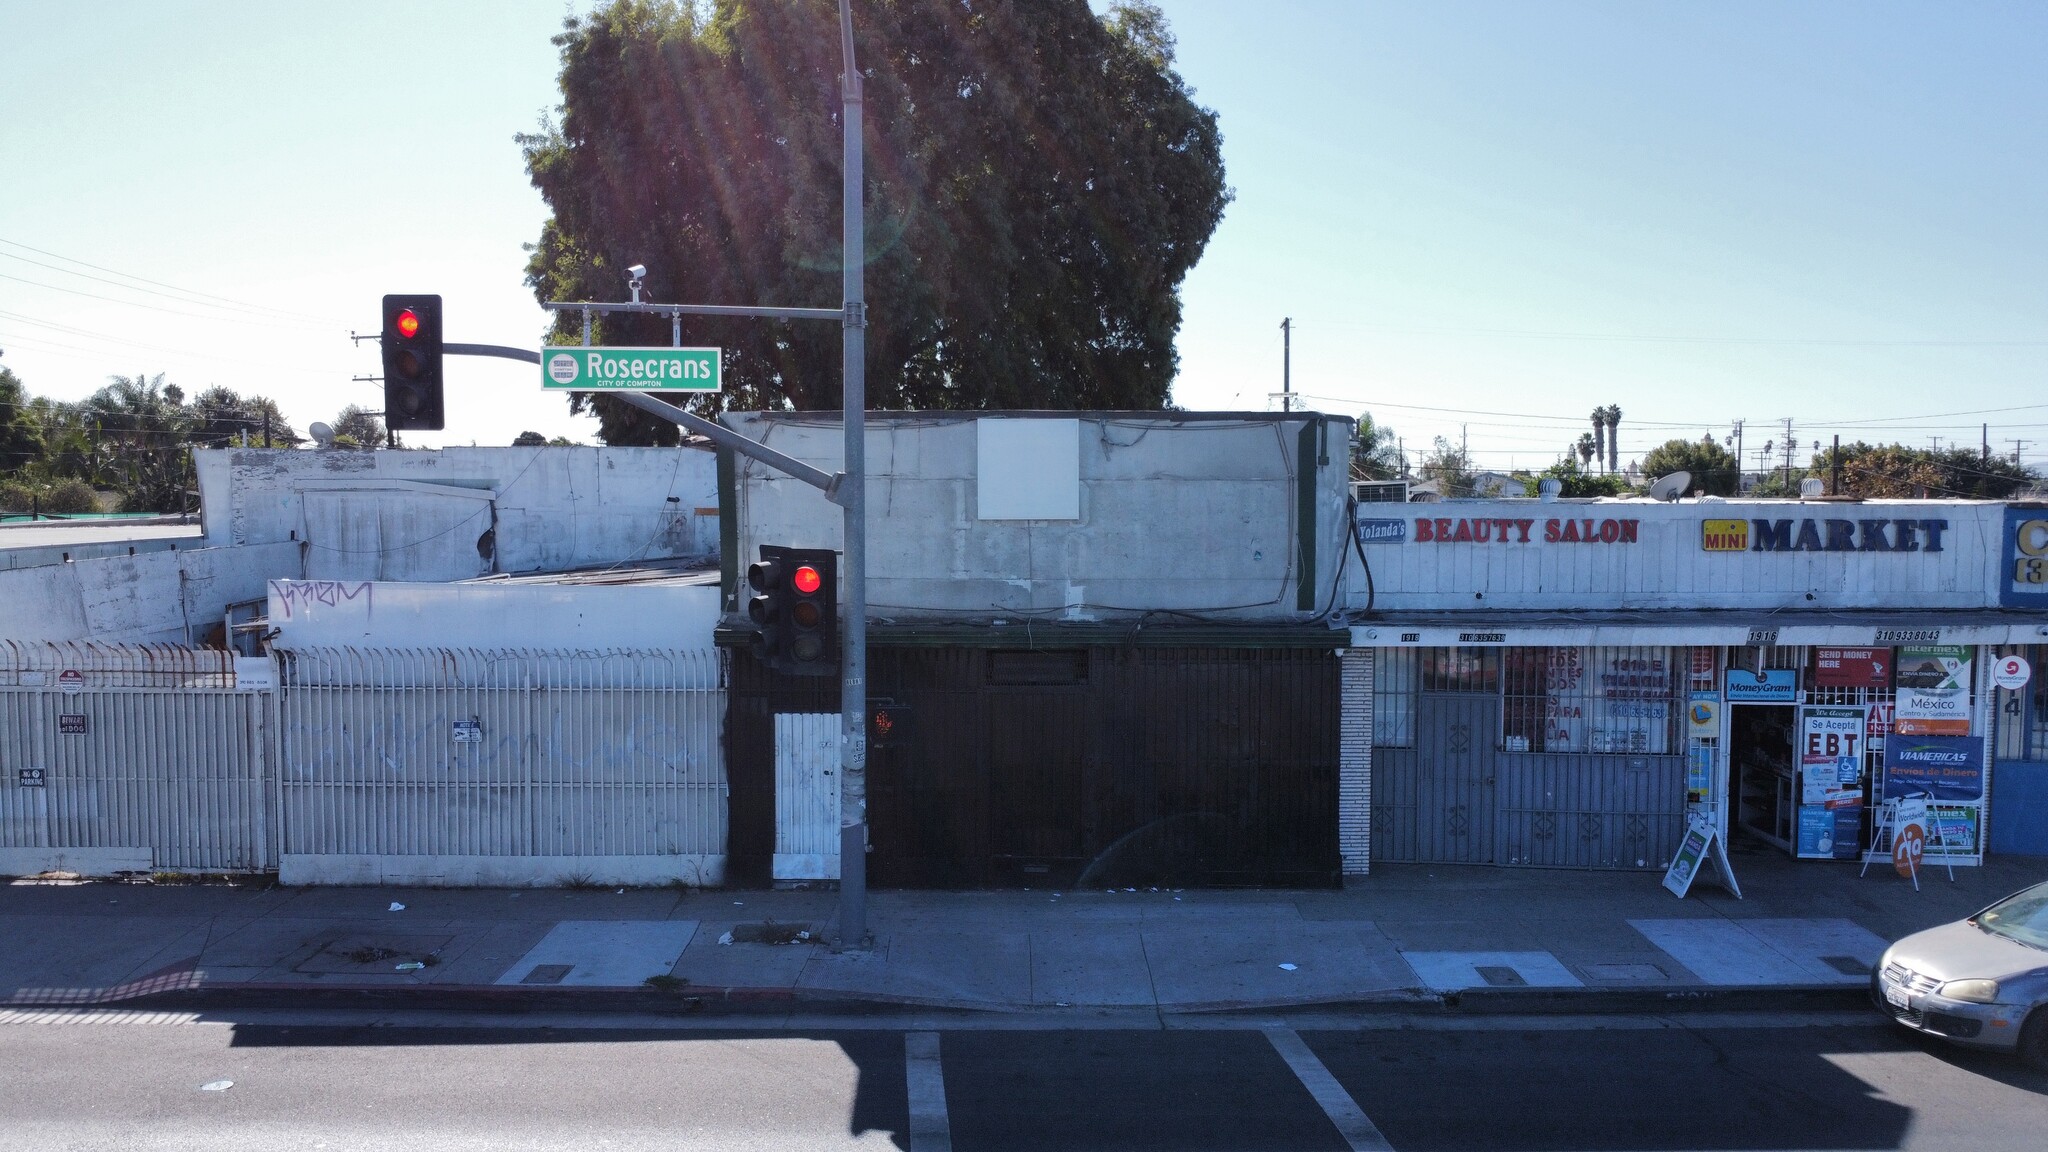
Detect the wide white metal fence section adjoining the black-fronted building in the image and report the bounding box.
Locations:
[279,648,727,883]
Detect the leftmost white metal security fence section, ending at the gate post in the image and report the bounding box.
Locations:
[0,642,276,875]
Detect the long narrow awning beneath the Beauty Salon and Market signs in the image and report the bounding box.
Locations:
[1352,611,2048,648]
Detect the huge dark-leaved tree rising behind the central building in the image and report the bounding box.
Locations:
[520,0,1229,443]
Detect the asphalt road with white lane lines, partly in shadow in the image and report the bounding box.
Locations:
[0,1013,2048,1152]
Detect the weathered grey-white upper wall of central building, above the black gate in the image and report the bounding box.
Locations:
[725,412,1350,621]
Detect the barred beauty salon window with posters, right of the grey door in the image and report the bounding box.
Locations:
[1501,648,1683,756]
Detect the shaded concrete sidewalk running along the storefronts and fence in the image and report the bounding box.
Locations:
[0,853,2048,1013]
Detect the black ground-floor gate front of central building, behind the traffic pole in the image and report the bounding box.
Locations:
[727,648,1341,888]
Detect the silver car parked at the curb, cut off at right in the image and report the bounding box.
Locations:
[1870,883,2048,1068]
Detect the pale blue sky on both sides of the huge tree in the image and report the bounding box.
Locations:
[0,0,2048,467]
